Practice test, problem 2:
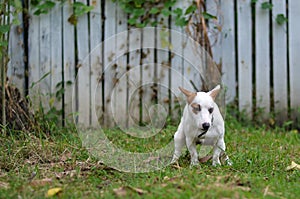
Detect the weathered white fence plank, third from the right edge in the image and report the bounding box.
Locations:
[255,0,270,118]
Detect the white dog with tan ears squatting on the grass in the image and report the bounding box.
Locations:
[171,85,231,166]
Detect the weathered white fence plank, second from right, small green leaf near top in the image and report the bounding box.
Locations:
[272,1,288,123]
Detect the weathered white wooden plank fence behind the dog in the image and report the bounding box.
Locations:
[8,0,300,126]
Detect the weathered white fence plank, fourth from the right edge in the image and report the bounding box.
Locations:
[236,0,253,116]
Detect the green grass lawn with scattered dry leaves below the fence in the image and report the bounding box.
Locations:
[0,118,300,198]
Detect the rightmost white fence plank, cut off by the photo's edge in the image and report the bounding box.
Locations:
[288,0,300,118]
